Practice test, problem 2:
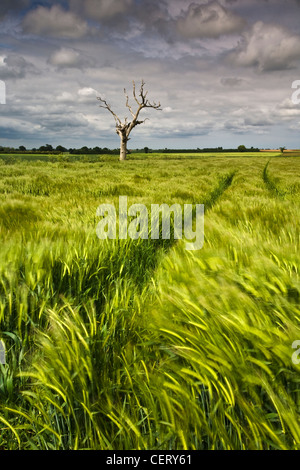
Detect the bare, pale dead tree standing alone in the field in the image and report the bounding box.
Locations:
[97,80,162,161]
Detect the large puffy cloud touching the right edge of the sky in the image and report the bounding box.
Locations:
[228,21,300,72]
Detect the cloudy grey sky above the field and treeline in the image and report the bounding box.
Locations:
[0,0,300,149]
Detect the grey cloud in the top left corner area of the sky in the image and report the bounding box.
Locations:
[22,5,88,38]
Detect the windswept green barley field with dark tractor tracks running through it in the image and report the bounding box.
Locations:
[0,152,300,450]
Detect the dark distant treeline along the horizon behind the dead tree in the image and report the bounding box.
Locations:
[0,144,260,155]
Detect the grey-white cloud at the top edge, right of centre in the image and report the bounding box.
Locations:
[177,0,246,38]
